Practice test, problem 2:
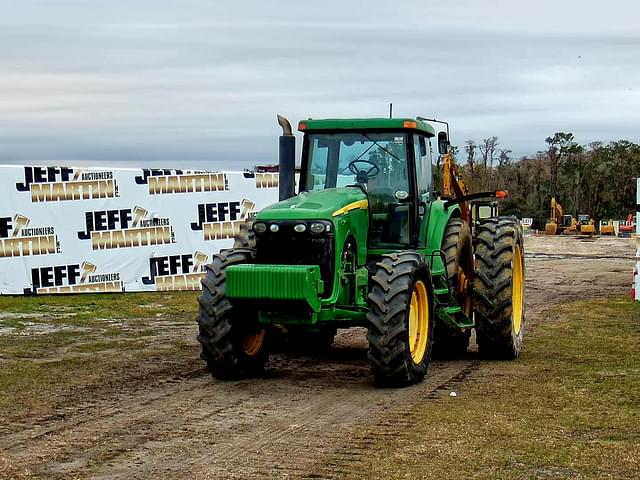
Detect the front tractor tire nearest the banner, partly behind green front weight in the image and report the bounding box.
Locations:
[198,249,269,380]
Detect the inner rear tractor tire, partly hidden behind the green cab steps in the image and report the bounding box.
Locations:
[433,218,473,358]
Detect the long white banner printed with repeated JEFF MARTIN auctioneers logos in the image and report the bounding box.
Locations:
[0,165,278,295]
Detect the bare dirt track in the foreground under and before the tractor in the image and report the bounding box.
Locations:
[0,332,480,478]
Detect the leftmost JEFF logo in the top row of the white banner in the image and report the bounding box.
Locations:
[16,167,118,203]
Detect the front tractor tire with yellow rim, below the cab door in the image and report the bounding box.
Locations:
[367,251,435,387]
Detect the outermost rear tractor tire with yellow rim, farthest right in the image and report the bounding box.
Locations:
[473,217,525,359]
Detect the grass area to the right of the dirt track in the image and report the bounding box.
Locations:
[312,299,640,479]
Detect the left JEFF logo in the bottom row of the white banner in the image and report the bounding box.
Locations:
[24,262,124,294]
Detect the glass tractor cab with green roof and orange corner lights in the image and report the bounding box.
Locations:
[299,119,434,248]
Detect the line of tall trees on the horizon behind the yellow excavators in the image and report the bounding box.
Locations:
[444,132,640,229]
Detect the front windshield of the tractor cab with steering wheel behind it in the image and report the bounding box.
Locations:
[305,132,409,195]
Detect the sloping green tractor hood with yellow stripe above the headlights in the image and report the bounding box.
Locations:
[256,187,368,221]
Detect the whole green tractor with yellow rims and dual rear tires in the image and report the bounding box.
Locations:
[198,117,524,386]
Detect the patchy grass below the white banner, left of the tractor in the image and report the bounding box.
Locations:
[0,292,199,421]
